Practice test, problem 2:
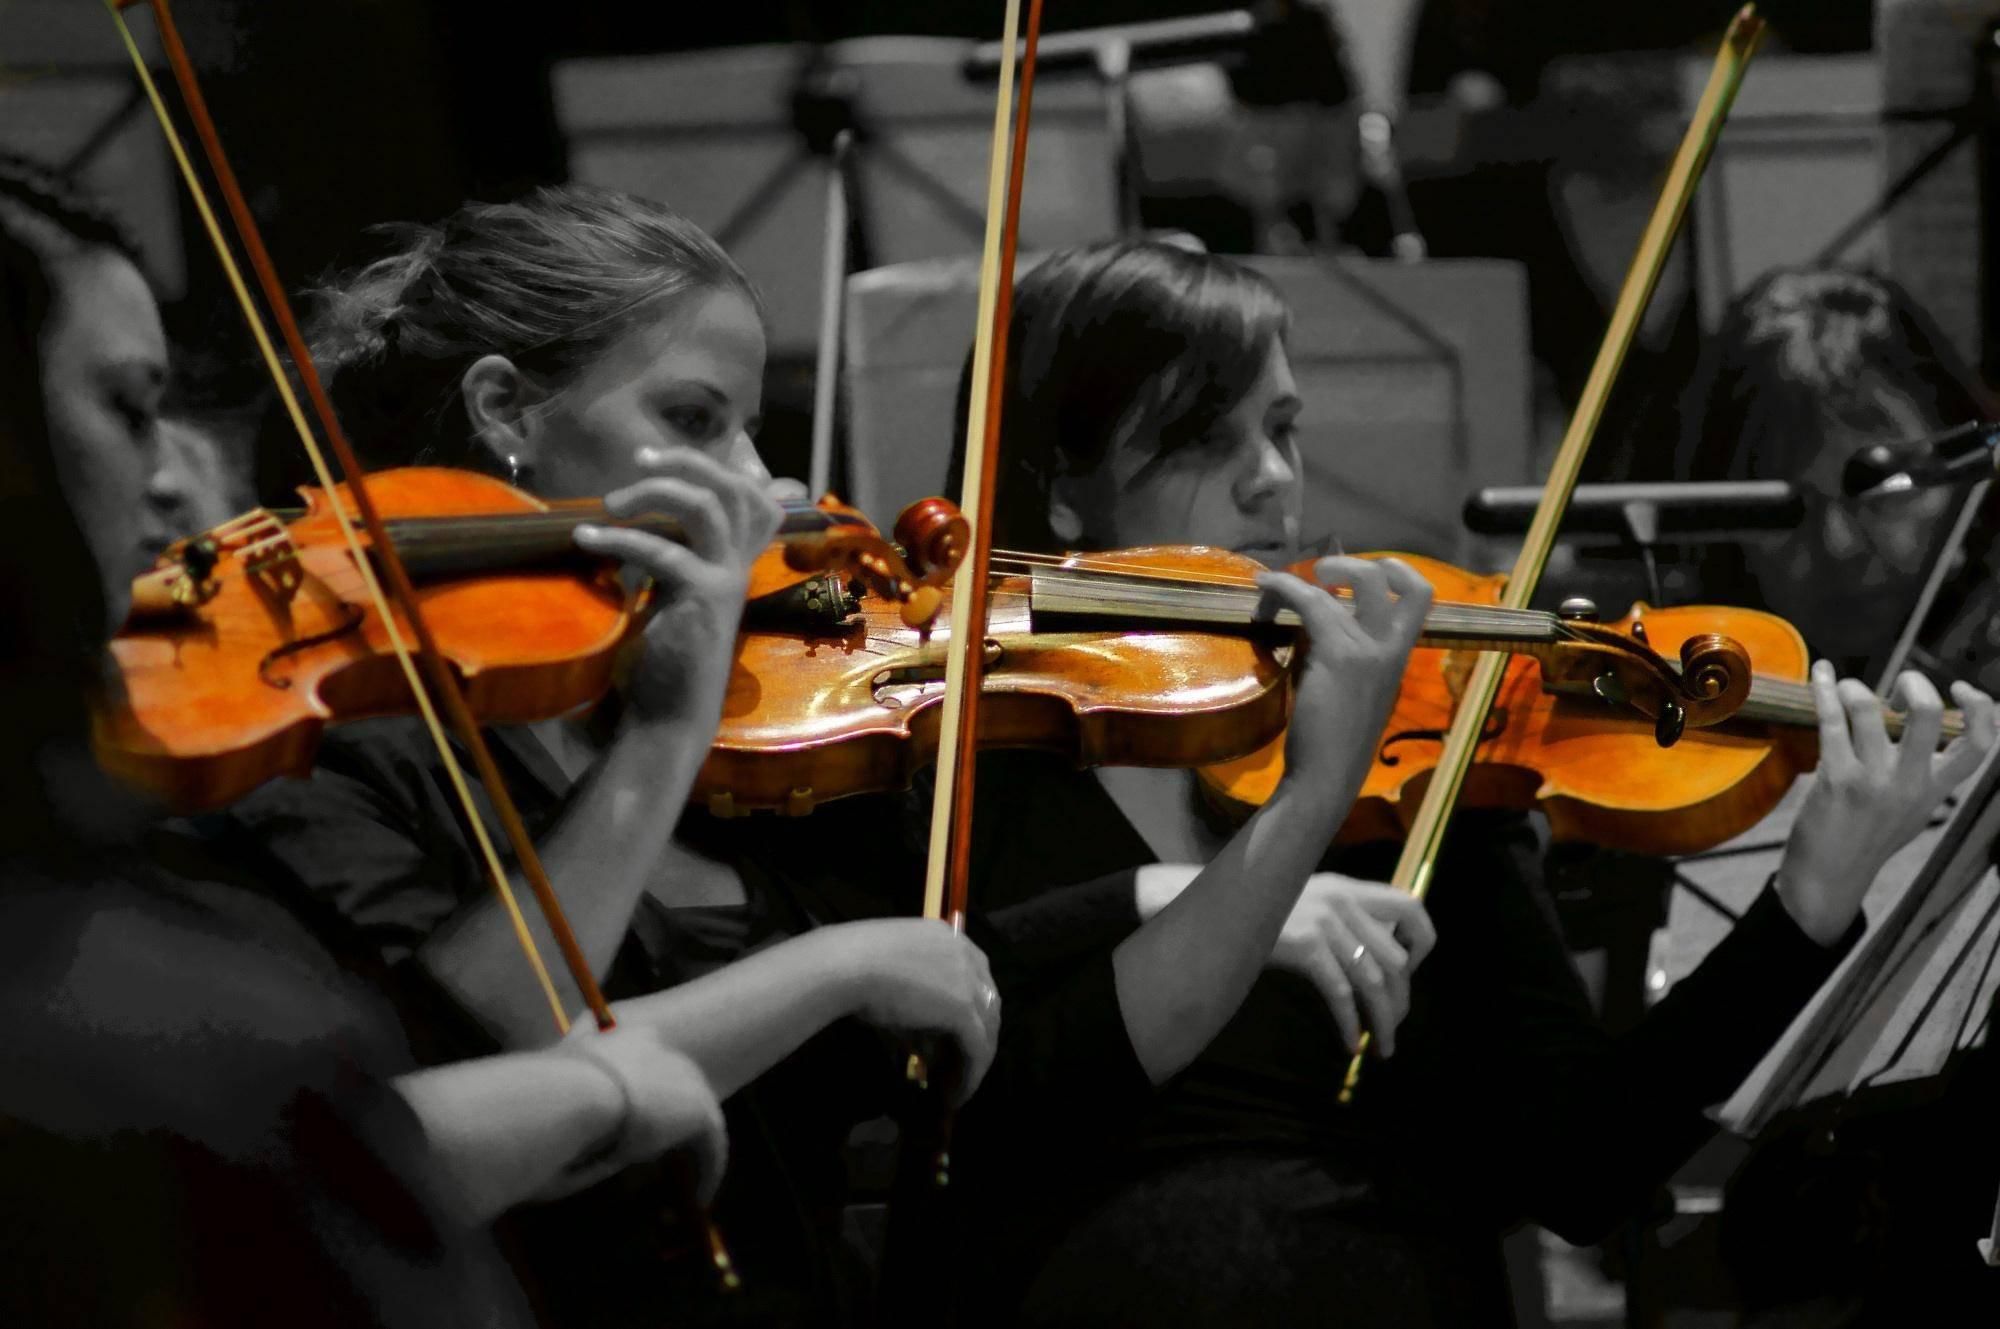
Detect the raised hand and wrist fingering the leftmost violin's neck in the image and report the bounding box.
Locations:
[576,450,782,721]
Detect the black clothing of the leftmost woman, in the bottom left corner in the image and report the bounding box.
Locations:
[0,861,532,1329]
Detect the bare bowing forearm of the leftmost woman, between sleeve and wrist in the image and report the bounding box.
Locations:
[394,1053,626,1225]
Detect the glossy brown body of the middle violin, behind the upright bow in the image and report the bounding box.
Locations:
[694,546,1290,815]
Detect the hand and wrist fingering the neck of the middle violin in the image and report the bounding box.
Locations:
[1256,558,1430,799]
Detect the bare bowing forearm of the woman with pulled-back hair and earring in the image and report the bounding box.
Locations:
[596,929,860,1099]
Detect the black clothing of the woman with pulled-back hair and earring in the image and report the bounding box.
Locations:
[198,721,1144,1325]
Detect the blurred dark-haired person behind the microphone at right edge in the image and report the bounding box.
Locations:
[1676,268,2000,1327]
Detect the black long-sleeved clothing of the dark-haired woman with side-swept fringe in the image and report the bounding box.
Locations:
[960,755,1858,1325]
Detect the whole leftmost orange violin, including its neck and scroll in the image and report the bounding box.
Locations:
[96,466,966,811]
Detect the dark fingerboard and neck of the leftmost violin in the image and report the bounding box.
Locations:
[388,500,856,580]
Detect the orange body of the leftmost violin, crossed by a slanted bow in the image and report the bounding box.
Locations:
[96,466,634,811]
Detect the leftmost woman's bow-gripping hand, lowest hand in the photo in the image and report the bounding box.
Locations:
[542,1023,730,1205]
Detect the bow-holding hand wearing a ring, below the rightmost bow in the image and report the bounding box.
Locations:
[1270,873,1438,1057]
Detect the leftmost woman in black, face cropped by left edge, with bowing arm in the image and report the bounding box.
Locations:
[0,162,722,1325]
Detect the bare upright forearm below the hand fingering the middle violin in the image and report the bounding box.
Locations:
[1112,787,1352,1085]
